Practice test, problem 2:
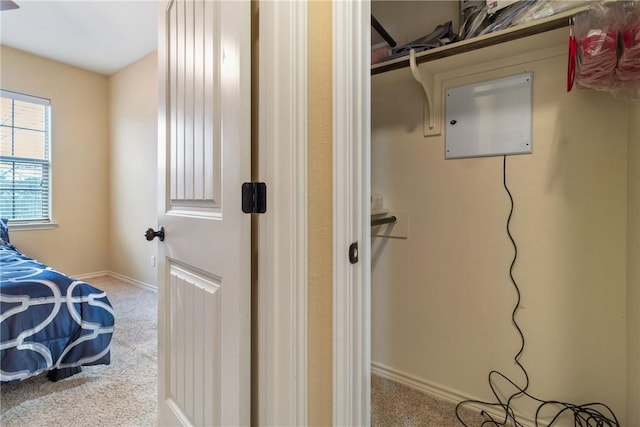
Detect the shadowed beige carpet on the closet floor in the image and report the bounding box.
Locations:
[371,374,485,427]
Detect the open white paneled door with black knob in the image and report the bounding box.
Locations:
[156,0,251,426]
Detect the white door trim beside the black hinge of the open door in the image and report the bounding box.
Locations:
[254,1,308,425]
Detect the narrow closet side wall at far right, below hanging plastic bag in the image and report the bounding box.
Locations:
[627,103,640,426]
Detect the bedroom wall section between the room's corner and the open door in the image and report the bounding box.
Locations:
[109,52,158,286]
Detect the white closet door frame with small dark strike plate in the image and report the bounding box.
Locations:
[333,0,371,426]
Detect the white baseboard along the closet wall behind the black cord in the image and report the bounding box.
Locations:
[371,362,546,426]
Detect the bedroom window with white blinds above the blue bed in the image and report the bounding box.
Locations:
[0,90,51,222]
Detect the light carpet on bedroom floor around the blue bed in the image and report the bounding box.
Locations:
[0,277,158,427]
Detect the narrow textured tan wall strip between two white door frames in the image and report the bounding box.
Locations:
[307,1,333,426]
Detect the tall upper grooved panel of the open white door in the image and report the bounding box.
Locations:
[168,1,222,208]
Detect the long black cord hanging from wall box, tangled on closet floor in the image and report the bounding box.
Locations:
[456,156,620,427]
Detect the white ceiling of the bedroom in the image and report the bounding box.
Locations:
[0,0,158,75]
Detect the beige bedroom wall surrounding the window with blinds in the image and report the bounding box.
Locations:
[0,46,109,275]
